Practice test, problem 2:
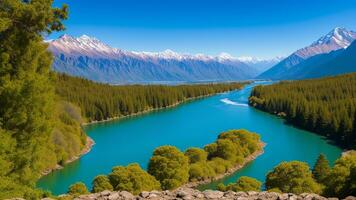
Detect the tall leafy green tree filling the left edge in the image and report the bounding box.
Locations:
[0,0,67,199]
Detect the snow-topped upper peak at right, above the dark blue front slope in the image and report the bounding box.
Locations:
[259,28,356,79]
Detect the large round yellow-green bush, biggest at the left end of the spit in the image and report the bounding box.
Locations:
[148,146,189,190]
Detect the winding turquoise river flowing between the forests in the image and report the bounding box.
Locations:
[38,83,341,194]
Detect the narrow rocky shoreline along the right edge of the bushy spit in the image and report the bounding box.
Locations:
[181,142,266,188]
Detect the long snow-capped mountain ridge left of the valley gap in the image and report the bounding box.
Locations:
[48,35,258,84]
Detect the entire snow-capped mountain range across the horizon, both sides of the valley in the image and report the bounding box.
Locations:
[48,28,356,84]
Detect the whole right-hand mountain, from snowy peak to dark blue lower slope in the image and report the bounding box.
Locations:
[258,28,356,80]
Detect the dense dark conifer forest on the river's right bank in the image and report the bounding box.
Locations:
[249,73,356,148]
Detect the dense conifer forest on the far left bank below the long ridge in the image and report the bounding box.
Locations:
[55,74,243,121]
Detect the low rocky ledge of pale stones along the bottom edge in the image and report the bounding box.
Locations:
[59,188,356,200]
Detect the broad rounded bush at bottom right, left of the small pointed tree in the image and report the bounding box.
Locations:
[266,161,321,194]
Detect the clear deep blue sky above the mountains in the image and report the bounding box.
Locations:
[50,0,356,58]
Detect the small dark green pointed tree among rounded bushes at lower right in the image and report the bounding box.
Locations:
[313,154,330,183]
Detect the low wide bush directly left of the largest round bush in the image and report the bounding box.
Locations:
[109,163,161,195]
